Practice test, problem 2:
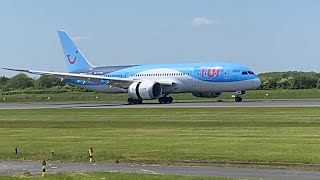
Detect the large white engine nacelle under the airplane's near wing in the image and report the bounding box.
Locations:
[128,81,162,99]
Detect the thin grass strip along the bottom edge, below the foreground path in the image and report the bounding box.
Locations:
[0,172,236,180]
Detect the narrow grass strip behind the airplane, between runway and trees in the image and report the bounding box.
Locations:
[0,89,320,102]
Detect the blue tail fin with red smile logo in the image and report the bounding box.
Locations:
[58,30,93,72]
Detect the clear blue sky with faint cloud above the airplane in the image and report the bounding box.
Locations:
[0,0,320,77]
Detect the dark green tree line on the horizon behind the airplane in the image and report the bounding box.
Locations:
[0,71,320,92]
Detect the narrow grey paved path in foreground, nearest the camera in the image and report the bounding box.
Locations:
[0,161,320,180]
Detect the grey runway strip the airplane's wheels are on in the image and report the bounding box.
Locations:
[0,100,320,109]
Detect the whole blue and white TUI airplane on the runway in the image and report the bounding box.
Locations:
[3,30,261,104]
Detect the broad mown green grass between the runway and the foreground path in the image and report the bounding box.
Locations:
[0,107,320,166]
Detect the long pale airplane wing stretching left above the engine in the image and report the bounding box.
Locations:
[2,68,175,89]
